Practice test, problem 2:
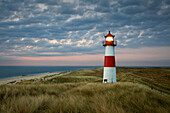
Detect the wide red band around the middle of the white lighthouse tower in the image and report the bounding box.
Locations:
[104,56,115,67]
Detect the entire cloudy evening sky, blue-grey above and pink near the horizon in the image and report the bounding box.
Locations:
[0,0,170,66]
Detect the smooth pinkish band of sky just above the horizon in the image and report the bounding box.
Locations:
[0,47,170,66]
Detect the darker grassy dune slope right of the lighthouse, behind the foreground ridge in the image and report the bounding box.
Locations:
[118,68,170,94]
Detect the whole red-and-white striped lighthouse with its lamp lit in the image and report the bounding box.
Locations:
[103,31,117,83]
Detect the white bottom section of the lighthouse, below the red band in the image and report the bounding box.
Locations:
[103,67,116,83]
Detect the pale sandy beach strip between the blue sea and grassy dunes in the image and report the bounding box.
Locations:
[0,72,61,85]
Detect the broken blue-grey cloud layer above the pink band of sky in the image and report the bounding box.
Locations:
[0,0,170,66]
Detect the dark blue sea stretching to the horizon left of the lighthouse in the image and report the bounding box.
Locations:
[0,66,102,79]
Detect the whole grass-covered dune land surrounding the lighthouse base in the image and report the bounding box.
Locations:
[0,68,170,113]
